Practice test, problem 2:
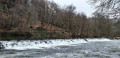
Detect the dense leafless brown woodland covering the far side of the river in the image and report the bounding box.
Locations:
[0,0,120,38]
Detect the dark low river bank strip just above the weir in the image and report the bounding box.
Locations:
[0,31,120,40]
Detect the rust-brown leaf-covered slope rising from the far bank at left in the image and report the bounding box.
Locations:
[0,21,72,40]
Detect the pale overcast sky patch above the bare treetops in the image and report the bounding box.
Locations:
[48,0,94,17]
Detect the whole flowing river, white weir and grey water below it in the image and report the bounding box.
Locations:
[0,38,120,58]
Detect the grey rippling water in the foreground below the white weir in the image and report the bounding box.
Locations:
[0,41,120,58]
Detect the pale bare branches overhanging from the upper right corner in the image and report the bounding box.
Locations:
[90,0,120,19]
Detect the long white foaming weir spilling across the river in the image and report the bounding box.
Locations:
[0,38,111,50]
